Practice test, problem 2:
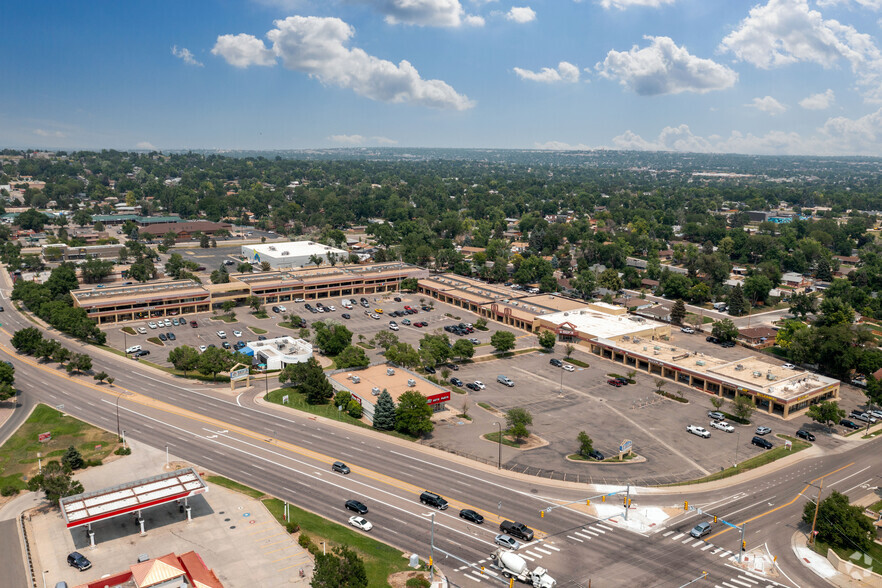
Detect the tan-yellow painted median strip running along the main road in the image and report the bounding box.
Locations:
[0,328,548,538]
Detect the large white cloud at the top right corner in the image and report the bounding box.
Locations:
[720,0,882,101]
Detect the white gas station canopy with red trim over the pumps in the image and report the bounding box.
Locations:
[59,467,208,529]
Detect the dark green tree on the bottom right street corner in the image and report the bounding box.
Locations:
[802,490,876,551]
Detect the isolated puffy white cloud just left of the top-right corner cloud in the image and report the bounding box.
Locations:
[594,36,738,96]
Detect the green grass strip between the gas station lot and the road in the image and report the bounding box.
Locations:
[207,476,409,586]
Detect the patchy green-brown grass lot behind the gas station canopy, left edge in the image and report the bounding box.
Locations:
[0,404,121,489]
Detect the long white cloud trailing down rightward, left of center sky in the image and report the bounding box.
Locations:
[212,16,474,110]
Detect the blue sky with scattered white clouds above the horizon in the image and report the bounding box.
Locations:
[0,0,882,156]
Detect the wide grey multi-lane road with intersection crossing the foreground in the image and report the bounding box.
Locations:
[0,304,880,587]
